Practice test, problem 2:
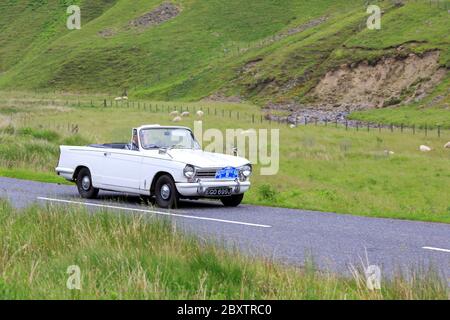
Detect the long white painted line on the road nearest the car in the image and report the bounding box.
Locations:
[37,197,272,228]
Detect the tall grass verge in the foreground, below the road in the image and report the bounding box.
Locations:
[0,201,448,299]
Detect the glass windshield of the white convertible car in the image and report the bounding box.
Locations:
[140,128,200,149]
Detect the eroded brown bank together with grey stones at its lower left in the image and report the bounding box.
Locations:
[265,51,448,126]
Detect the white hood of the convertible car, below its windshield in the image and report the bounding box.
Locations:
[163,149,249,168]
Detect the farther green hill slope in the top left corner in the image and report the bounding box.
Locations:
[0,0,116,76]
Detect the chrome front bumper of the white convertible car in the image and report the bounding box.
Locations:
[175,180,250,197]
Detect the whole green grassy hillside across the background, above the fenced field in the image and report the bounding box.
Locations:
[0,0,450,111]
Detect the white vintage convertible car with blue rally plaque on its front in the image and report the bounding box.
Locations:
[56,125,252,208]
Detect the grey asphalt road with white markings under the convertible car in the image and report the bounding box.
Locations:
[0,178,450,284]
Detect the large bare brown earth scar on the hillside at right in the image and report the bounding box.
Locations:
[311,51,448,110]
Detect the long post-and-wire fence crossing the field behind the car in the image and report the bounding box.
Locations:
[11,99,450,138]
